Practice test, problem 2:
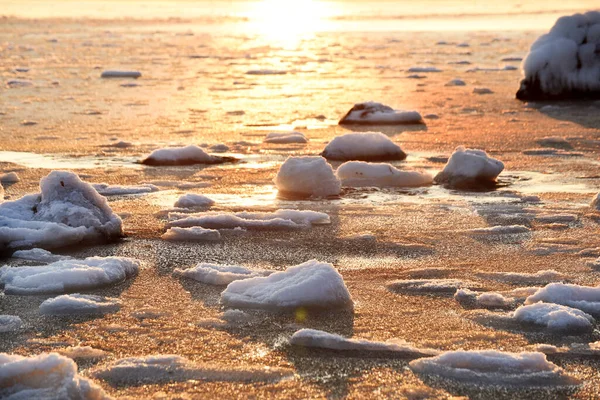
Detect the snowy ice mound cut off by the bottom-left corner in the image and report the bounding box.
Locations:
[0,353,110,400]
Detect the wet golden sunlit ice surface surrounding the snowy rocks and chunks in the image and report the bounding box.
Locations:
[0,3,600,398]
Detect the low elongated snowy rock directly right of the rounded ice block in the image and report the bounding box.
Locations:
[336,161,433,187]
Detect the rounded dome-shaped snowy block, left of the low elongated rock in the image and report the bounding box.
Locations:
[274,157,342,197]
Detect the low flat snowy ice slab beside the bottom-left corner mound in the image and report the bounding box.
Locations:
[93,354,293,386]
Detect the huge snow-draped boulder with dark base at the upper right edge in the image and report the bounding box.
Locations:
[517,11,600,100]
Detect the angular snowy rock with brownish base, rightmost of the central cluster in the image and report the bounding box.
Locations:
[434,146,504,187]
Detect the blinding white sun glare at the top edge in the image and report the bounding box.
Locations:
[248,0,332,47]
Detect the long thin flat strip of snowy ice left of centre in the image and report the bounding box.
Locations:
[167,210,331,230]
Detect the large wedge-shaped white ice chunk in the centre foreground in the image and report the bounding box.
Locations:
[221,260,353,309]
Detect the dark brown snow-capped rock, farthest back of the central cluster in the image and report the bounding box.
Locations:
[339,101,425,125]
